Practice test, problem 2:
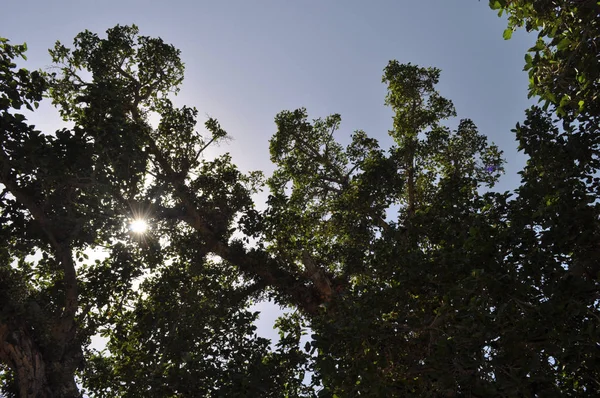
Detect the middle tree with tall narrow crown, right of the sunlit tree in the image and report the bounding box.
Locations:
[263,61,502,396]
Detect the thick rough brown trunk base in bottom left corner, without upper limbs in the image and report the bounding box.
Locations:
[0,325,81,398]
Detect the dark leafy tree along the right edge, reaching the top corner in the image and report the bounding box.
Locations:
[490,1,600,396]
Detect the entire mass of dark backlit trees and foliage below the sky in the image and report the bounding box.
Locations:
[0,0,600,398]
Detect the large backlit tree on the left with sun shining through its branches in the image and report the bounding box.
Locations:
[0,26,314,397]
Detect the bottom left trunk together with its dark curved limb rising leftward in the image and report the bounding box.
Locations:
[0,151,82,398]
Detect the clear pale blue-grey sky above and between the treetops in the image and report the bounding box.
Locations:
[0,0,535,337]
